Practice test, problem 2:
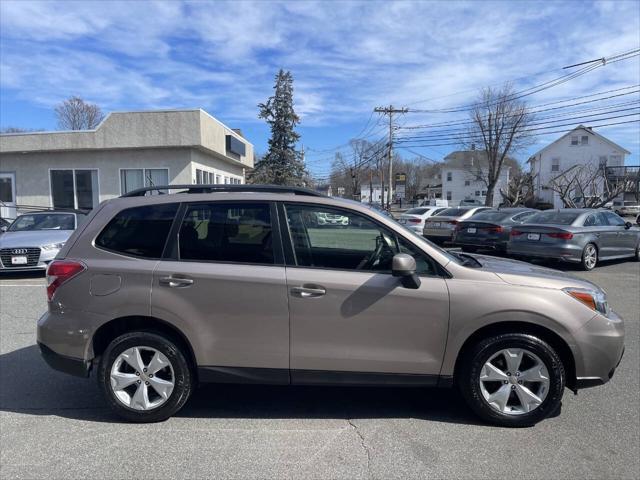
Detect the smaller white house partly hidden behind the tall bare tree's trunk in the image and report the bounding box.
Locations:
[442,150,517,207]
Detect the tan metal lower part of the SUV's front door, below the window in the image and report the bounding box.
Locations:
[287,268,449,376]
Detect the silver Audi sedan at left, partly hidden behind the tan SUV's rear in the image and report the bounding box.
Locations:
[0,211,84,272]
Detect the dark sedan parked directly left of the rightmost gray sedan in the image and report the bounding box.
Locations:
[453,208,538,253]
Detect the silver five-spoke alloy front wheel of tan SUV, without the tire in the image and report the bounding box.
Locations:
[479,348,549,415]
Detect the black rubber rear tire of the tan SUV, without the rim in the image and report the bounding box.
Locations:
[97,331,194,423]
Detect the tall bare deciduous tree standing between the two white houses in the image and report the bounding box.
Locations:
[461,84,533,206]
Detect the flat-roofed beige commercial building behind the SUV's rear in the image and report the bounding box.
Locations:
[0,109,254,218]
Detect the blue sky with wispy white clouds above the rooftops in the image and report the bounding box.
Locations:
[0,0,640,175]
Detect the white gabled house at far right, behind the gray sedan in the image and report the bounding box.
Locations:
[528,125,630,208]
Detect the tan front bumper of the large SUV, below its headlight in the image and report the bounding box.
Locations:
[574,312,625,389]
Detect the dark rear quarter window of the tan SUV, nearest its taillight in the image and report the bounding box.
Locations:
[96,203,178,258]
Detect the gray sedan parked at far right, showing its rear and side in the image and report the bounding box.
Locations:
[507,209,640,270]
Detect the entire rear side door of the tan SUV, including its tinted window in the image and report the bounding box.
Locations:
[151,201,289,374]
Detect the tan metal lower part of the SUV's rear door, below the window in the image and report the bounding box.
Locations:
[151,260,289,369]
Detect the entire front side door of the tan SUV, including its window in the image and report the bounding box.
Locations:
[279,203,449,383]
